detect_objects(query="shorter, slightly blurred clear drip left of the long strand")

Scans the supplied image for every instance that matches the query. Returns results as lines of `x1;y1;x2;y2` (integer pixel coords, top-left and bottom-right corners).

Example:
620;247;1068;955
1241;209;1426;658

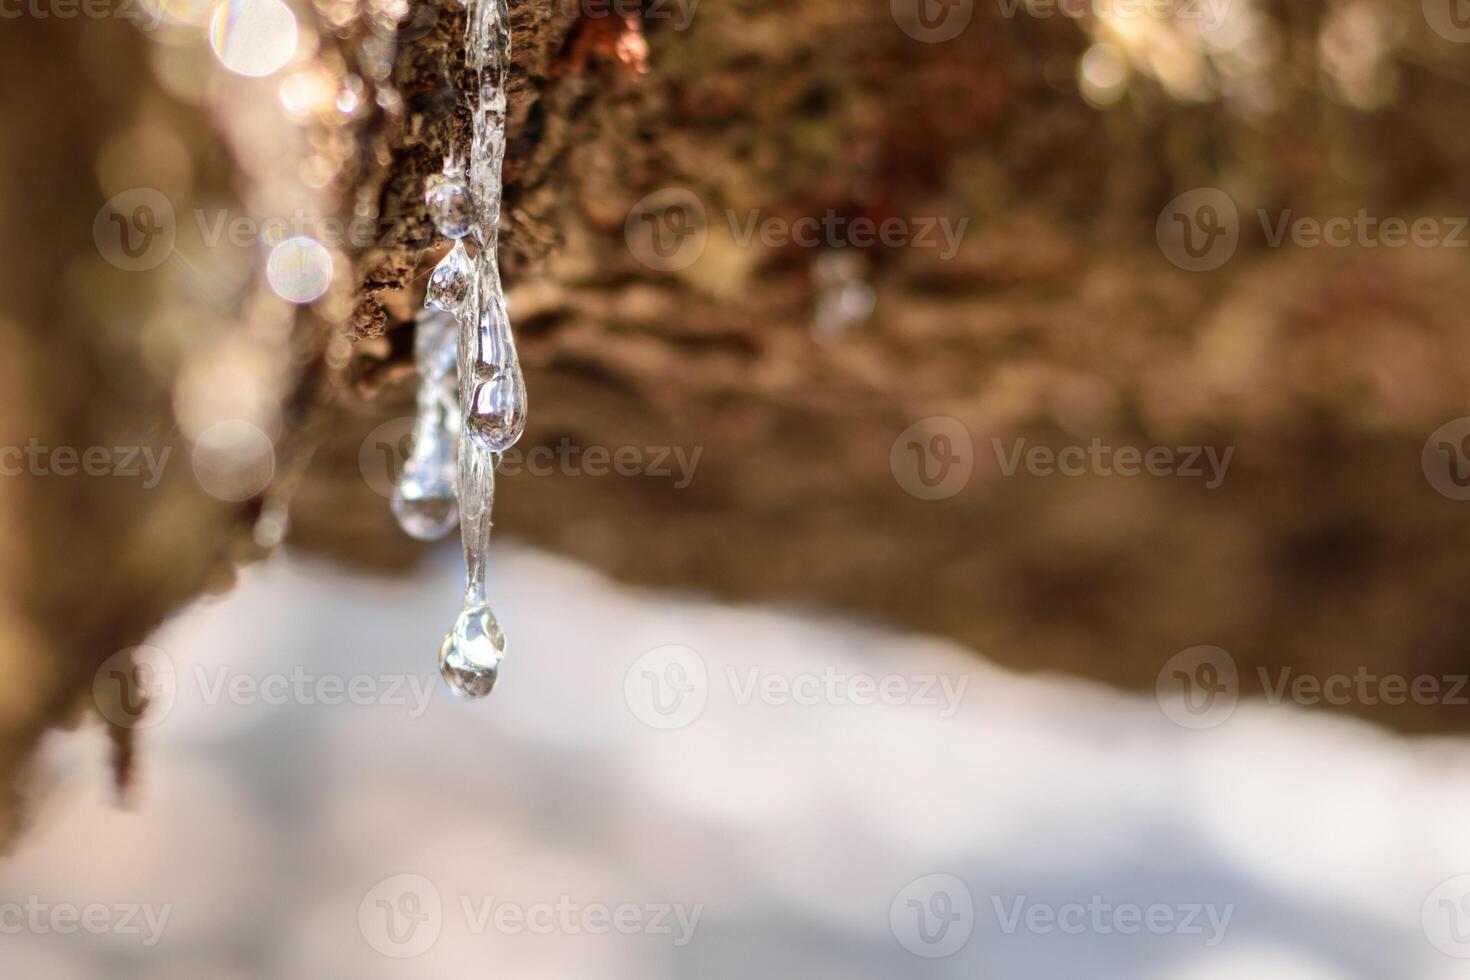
392;310;460;541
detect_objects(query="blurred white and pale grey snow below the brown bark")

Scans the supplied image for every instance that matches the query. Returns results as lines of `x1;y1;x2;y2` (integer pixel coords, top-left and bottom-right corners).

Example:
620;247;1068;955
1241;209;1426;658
0;545;1470;980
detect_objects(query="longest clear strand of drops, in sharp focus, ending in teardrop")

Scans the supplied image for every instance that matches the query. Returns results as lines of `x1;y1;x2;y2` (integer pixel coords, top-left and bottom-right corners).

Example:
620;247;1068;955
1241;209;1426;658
426;0;526;698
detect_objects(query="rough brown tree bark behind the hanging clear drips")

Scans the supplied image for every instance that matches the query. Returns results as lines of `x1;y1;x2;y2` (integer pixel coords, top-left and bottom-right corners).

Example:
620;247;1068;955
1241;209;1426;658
0;0;1470;840
